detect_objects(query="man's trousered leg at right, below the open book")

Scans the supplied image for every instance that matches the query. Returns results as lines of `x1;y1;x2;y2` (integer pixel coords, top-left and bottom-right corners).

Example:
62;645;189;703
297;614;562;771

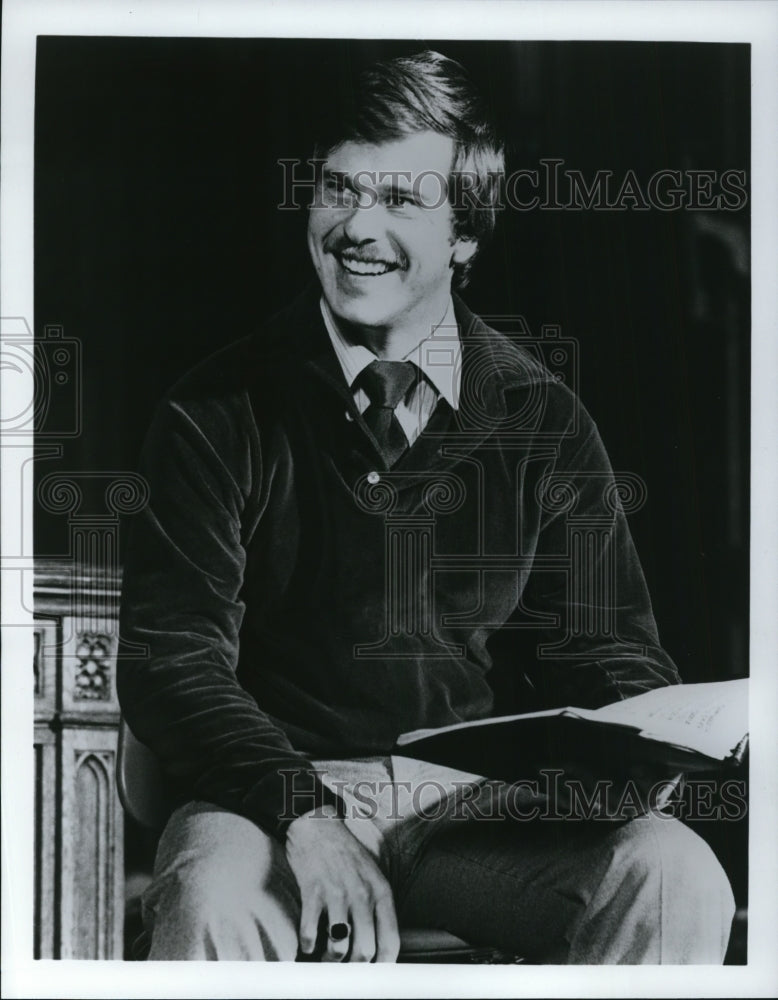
397;792;734;964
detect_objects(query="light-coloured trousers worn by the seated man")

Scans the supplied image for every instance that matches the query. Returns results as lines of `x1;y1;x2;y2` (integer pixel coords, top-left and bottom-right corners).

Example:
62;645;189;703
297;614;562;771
143;757;734;964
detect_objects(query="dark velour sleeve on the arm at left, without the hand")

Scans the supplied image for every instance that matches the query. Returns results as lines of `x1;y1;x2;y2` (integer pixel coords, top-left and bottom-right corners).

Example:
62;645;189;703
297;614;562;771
118;390;343;839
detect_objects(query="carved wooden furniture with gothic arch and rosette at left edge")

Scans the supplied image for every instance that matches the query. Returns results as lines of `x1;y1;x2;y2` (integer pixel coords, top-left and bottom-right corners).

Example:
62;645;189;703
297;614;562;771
32;563;124;959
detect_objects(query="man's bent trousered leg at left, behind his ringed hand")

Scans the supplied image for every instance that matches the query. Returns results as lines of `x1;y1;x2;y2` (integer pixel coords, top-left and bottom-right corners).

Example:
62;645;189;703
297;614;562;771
143;802;300;960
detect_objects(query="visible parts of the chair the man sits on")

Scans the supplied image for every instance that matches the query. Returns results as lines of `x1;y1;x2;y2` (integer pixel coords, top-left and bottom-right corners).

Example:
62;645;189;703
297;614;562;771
116;719;522;964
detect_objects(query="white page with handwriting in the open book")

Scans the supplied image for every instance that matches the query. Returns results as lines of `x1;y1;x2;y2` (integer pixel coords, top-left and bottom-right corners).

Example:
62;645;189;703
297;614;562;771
578;679;748;760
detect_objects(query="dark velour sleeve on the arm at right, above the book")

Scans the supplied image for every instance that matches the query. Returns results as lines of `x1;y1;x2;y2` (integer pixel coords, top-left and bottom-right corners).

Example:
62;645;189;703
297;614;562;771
522;378;680;708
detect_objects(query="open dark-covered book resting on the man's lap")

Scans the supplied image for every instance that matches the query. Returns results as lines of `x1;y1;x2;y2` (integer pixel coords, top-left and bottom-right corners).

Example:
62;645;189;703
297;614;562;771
395;679;748;781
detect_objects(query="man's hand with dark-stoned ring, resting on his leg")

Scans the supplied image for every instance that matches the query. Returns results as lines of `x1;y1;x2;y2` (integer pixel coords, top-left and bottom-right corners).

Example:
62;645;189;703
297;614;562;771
286;807;400;962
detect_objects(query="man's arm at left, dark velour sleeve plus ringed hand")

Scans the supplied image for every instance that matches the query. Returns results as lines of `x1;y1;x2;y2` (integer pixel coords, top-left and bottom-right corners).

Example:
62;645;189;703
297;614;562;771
118;386;399;961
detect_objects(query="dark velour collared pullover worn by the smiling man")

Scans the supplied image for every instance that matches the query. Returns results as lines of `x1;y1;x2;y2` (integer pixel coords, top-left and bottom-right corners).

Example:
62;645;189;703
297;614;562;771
118;291;678;835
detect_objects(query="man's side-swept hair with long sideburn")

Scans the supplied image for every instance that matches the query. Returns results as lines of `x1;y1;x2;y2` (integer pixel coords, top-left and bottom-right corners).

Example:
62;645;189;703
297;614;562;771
315;49;505;288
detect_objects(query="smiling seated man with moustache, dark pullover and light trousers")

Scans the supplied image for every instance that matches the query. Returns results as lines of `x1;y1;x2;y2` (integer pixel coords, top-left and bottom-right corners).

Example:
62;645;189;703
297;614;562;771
119;52;732;963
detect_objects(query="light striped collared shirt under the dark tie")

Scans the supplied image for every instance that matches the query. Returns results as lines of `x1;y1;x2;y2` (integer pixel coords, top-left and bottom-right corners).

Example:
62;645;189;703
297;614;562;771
320;296;462;444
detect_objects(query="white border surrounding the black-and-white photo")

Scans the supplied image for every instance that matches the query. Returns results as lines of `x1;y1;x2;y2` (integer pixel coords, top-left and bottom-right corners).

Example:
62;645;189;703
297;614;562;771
0;0;778;997
